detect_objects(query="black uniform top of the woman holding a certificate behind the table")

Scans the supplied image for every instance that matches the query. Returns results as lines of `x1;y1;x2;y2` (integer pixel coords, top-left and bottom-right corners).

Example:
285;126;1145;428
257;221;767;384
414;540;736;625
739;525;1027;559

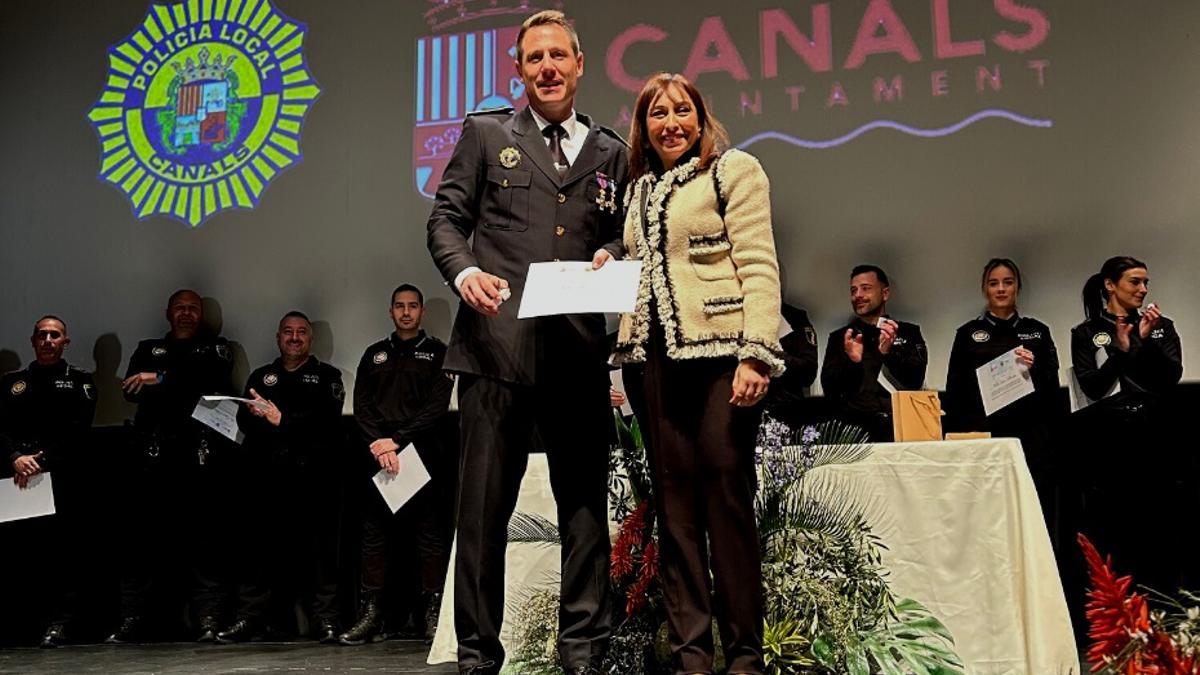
946;312;1058;435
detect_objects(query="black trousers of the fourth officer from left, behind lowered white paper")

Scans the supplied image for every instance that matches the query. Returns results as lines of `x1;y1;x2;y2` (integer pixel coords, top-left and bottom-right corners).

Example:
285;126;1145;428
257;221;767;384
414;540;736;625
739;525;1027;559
362;448;457;593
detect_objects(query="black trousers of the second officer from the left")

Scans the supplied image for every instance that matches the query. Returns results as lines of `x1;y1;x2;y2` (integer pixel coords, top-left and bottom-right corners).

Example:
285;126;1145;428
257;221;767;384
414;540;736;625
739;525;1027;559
120;453;228;617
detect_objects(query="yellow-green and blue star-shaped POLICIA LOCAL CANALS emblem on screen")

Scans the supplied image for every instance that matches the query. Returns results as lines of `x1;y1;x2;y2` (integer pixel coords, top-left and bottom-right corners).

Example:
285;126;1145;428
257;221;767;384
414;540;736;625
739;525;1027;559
88;0;320;227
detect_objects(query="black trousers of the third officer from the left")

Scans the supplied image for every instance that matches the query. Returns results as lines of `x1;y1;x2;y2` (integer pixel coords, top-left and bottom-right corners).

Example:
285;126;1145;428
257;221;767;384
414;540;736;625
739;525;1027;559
229;467;341;625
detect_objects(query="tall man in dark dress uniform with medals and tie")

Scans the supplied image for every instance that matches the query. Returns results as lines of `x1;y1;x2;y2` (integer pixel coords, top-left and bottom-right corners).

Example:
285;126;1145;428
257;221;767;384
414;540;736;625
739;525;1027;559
428;11;628;674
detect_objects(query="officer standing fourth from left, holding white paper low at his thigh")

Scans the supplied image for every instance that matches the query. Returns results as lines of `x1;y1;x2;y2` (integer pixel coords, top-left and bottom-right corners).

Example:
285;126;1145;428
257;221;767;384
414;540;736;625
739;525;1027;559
338;283;457;645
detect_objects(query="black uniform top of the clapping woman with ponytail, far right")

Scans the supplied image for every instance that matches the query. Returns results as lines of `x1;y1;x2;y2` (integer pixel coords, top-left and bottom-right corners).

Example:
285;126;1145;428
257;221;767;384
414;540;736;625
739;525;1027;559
1070;312;1183;400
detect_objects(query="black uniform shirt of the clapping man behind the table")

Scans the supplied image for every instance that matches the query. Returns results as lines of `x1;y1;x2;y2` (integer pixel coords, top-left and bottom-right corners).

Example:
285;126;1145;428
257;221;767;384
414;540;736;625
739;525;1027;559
821;317;929;413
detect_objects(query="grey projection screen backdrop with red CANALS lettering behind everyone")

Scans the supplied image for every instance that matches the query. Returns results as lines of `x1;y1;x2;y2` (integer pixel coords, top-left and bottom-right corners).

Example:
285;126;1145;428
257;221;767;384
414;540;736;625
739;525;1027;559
0;0;1200;423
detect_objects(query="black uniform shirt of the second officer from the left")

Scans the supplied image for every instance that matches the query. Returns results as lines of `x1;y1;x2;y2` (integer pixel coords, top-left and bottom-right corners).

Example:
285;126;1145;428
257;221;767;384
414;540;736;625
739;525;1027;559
125;335;233;435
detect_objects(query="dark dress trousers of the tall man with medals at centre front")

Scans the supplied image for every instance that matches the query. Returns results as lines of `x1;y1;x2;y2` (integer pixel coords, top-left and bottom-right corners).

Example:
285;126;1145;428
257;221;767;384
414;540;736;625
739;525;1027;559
455;369;612;668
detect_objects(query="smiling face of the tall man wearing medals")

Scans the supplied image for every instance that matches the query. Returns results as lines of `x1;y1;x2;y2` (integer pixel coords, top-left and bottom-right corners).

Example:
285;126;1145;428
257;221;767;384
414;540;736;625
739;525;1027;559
515;24;583;117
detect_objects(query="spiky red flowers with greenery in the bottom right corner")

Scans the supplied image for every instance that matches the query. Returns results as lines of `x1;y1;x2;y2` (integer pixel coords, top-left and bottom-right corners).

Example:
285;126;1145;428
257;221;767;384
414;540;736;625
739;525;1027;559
1078;533;1200;675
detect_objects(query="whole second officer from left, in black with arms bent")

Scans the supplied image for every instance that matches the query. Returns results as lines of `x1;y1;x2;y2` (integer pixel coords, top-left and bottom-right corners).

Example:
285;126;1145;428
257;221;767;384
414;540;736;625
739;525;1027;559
107;289;233;644
